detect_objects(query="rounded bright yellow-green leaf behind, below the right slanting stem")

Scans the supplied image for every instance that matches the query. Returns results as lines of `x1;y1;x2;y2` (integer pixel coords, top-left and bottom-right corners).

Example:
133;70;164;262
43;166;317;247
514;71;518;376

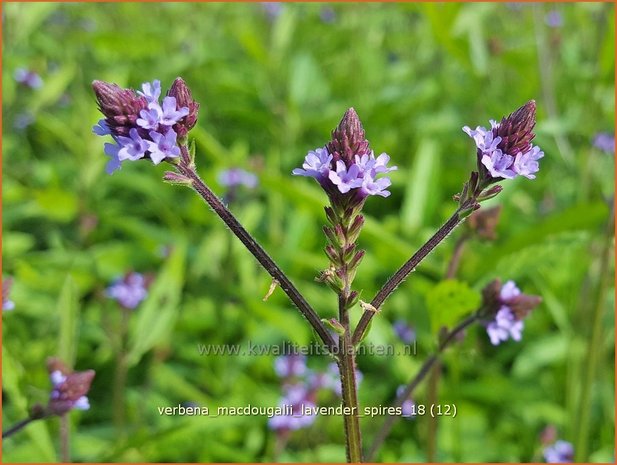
426;279;482;334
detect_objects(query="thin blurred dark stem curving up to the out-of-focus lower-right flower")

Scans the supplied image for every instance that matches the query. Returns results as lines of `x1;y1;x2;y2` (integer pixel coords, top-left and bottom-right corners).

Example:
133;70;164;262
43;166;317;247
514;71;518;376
366;312;479;462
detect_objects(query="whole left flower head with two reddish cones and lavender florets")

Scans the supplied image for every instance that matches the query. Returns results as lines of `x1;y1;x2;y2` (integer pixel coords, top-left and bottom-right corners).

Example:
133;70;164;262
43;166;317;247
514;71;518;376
92;78;191;174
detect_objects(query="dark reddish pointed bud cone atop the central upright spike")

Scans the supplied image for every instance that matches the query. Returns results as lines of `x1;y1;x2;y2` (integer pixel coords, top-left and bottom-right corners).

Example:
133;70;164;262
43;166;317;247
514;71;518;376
326;108;371;167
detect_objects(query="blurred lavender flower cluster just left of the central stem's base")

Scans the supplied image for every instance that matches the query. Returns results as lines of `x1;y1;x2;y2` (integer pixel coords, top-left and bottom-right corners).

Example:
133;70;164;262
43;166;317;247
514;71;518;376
268;354;362;432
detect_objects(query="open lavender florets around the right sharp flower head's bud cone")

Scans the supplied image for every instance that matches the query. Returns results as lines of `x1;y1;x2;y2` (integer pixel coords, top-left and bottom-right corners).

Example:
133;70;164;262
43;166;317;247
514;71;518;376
463;110;544;179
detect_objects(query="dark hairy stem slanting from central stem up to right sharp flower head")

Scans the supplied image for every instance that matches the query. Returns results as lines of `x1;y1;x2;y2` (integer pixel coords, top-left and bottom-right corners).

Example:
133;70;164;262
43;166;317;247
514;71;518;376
352;209;464;345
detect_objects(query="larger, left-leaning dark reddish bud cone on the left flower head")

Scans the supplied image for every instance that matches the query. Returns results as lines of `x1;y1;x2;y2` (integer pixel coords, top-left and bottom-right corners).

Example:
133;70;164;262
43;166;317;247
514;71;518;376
92;81;148;137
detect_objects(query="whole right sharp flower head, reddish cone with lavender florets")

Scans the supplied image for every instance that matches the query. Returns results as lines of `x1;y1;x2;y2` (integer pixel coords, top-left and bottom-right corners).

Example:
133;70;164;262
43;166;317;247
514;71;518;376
463;100;544;181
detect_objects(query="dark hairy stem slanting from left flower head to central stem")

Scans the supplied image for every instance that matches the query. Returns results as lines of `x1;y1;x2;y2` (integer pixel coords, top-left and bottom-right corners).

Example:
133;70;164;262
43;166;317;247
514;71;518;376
176;149;336;352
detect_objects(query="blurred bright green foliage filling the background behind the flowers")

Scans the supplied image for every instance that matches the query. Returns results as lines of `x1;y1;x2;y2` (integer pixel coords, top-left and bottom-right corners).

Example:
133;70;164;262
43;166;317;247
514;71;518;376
2;3;615;462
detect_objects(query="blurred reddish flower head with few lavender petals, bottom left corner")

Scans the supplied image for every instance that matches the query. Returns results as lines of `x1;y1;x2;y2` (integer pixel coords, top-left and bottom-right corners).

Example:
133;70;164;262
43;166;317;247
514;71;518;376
47;358;95;415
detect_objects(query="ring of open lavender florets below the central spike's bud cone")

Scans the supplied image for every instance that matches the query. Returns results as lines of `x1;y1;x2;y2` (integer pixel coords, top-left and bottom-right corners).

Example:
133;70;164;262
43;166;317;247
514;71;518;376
292;147;397;197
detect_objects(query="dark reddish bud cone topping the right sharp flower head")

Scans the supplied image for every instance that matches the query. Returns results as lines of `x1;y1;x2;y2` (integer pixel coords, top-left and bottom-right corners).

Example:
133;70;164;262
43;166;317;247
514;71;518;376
493;100;536;156
